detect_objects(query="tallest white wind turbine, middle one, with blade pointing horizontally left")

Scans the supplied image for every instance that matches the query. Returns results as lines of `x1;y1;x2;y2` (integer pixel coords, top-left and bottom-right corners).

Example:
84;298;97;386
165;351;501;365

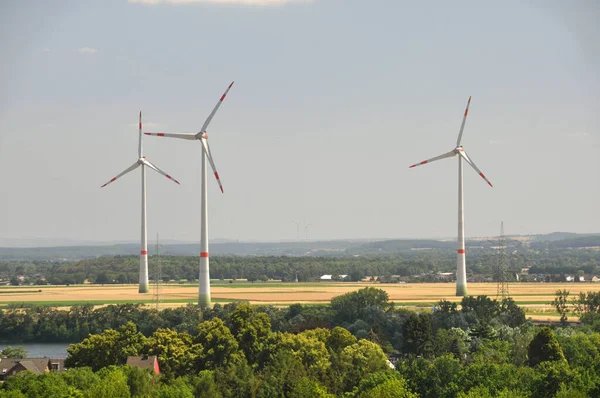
144;82;234;308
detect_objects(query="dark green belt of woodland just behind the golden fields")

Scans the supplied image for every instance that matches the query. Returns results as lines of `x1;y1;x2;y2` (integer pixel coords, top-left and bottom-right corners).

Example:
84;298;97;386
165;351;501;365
0;249;600;284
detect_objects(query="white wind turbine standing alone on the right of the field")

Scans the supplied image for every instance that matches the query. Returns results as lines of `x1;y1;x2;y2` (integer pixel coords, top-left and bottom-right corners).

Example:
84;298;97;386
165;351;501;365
410;97;493;296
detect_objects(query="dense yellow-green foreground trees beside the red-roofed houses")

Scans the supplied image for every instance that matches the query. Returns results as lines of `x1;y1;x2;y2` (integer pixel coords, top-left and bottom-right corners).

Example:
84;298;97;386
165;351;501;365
5;288;600;398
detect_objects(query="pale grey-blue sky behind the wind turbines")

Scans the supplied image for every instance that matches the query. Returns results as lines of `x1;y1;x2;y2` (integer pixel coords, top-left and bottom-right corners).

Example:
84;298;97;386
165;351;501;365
0;0;600;241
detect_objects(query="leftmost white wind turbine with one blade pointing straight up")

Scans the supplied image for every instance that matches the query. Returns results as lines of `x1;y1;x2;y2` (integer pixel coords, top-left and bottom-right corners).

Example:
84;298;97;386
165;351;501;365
101;111;179;293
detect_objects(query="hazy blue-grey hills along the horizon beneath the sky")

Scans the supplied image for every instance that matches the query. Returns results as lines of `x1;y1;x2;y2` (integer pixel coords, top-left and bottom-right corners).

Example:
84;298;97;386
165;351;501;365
0;232;600;261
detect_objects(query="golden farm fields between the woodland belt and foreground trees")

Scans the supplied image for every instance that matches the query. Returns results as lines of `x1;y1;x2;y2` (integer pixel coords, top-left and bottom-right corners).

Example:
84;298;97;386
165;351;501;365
0;281;600;320
